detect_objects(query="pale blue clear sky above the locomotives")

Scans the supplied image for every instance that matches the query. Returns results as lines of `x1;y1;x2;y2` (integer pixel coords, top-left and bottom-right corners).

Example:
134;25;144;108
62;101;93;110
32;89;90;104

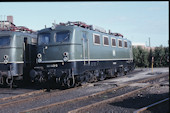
0;1;169;47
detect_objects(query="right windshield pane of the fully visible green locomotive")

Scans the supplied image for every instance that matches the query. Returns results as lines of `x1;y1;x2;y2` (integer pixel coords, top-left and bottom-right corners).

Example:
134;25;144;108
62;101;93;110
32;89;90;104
55;31;70;43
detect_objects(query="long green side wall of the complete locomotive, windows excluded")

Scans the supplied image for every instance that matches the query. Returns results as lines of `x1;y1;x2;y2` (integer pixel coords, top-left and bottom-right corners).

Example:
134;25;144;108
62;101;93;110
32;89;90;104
70;27;133;74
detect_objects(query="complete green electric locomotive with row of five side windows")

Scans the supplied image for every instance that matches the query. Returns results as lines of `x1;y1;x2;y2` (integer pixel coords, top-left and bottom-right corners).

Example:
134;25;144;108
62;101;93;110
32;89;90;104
30;21;134;88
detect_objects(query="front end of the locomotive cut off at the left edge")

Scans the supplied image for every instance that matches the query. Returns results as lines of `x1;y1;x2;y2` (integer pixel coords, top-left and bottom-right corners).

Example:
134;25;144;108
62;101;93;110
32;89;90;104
0;32;23;85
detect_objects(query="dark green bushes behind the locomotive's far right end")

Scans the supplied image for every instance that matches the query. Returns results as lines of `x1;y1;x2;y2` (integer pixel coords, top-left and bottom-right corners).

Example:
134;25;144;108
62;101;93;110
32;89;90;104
133;45;169;67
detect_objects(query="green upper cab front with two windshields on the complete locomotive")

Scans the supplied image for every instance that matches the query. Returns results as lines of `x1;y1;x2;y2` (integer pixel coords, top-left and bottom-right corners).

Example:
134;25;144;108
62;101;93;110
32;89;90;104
37;27;72;63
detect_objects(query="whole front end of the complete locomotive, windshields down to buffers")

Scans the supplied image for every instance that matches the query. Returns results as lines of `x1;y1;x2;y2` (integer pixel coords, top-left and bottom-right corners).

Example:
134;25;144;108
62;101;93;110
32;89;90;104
30;26;72;87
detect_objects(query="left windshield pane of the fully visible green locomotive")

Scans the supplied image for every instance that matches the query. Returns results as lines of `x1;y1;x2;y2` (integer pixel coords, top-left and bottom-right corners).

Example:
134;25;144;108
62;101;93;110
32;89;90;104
38;33;50;45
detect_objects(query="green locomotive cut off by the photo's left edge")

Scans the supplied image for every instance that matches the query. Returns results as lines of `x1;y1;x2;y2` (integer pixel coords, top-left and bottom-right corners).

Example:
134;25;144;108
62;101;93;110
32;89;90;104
0;26;37;87
